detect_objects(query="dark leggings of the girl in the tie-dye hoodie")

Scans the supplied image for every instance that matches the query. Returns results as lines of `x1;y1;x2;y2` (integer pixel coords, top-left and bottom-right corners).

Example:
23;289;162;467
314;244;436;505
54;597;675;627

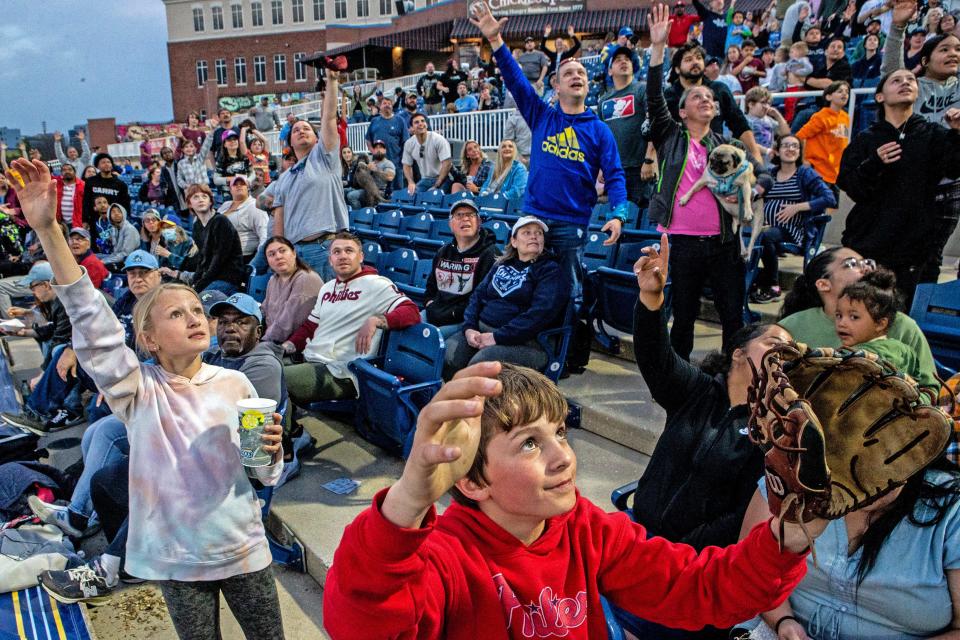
159;567;284;640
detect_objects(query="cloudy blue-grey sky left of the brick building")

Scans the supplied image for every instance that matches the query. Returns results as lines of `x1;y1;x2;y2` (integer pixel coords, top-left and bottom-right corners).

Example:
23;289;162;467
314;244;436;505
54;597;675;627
0;0;172;135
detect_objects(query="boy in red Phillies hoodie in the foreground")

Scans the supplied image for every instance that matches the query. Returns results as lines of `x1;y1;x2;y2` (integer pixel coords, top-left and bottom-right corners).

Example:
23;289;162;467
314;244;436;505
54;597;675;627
323;358;825;640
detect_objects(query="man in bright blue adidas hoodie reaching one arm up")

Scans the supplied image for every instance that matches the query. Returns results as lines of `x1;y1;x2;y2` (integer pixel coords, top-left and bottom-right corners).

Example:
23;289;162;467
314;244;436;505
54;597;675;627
470;2;628;292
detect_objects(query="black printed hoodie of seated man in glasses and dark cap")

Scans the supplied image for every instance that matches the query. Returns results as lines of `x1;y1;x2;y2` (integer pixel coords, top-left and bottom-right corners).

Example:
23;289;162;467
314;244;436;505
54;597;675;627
425;227;500;327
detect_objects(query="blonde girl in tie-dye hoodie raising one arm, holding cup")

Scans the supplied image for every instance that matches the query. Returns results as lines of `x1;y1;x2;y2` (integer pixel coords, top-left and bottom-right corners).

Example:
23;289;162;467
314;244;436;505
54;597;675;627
6;160;283;639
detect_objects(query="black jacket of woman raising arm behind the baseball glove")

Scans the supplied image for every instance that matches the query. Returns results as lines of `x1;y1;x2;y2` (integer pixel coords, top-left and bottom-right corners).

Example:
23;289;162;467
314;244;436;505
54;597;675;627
633;303;763;550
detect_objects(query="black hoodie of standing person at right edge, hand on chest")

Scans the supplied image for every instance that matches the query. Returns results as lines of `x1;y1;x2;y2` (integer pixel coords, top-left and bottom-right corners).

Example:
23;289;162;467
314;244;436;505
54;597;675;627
837;115;960;268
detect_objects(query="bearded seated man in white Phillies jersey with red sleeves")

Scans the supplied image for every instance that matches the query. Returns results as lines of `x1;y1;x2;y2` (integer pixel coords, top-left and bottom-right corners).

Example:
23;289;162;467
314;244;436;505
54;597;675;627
282;231;420;407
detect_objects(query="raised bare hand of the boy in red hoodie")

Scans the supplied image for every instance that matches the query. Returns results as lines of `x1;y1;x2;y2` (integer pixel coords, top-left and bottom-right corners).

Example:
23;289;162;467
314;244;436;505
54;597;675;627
382;362;502;527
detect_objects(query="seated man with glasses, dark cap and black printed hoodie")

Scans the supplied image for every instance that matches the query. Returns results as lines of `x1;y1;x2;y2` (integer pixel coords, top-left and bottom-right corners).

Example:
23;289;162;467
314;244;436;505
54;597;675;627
422;200;499;338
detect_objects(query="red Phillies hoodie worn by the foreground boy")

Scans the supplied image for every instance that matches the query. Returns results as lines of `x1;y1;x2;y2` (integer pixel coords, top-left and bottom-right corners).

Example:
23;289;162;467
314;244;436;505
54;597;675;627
323;489;806;640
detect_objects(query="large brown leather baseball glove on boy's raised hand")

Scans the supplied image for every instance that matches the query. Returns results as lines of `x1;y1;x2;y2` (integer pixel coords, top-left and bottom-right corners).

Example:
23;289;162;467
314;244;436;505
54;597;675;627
749;344;951;524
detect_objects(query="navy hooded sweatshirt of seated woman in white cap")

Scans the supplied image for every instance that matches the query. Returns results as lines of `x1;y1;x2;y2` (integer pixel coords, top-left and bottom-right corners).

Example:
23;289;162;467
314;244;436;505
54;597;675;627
463;253;570;345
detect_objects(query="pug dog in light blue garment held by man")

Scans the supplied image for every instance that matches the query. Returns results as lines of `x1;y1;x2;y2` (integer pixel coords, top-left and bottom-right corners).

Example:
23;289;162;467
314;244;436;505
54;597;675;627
680;140;763;257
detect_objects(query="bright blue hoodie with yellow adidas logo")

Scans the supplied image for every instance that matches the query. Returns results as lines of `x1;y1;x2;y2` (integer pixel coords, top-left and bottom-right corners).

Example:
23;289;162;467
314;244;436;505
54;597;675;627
493;46;627;226
